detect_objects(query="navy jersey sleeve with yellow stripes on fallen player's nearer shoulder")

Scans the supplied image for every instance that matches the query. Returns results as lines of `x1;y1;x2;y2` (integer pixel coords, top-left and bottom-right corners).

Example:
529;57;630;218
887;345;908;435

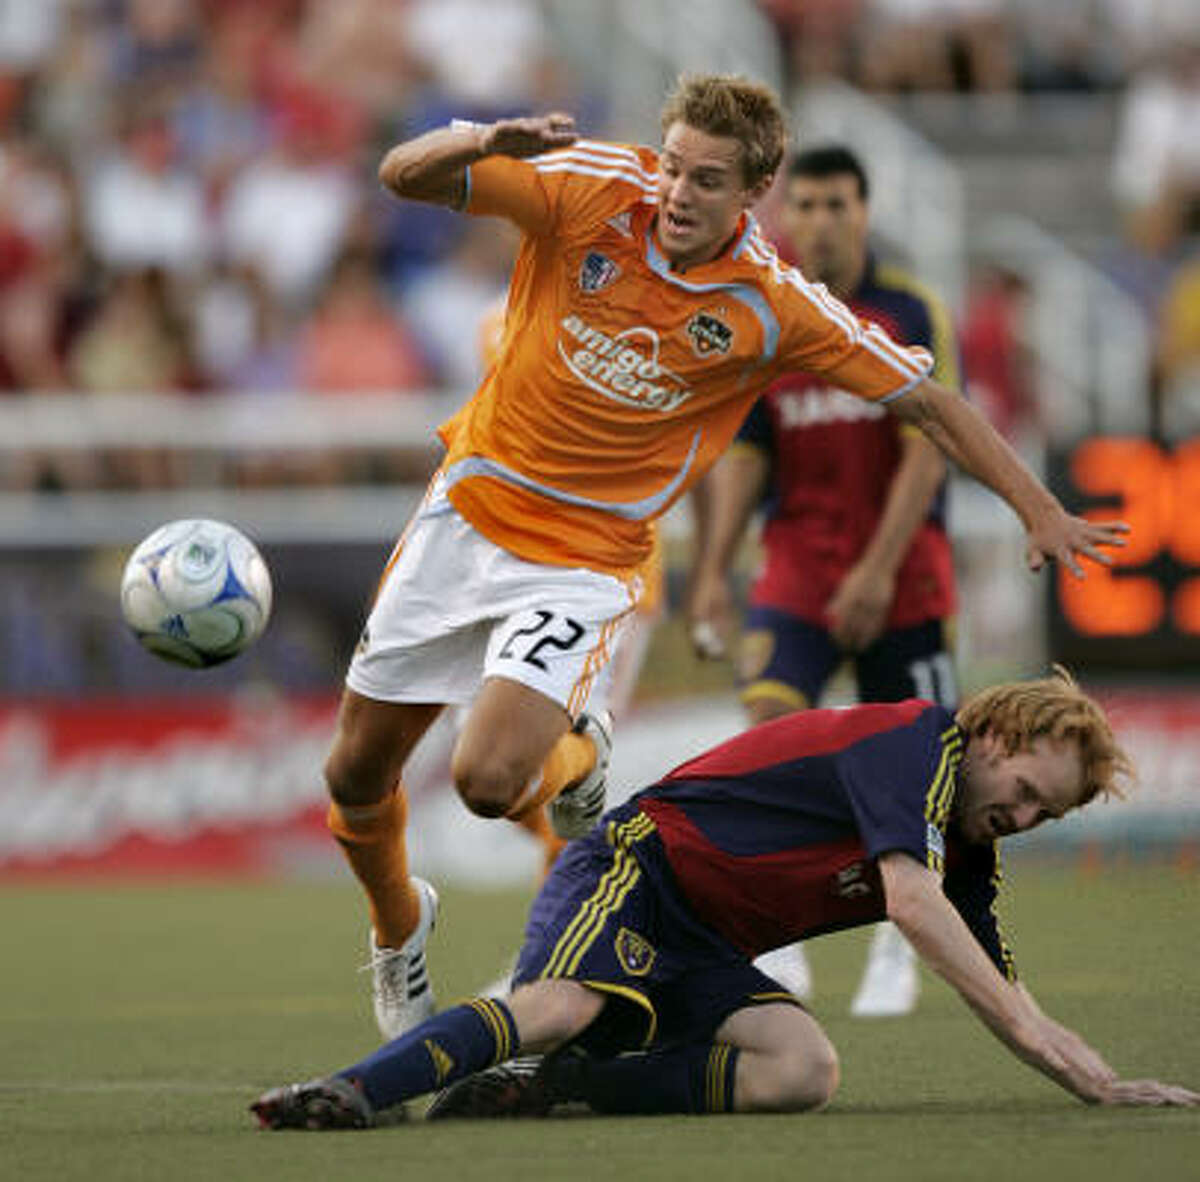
838;707;962;875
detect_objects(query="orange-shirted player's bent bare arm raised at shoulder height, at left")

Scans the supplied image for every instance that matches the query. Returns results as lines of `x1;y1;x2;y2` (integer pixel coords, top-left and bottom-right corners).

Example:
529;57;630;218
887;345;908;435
379;112;576;209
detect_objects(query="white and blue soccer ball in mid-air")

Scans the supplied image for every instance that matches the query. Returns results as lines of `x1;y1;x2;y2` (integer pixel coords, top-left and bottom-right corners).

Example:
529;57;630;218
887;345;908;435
121;520;271;668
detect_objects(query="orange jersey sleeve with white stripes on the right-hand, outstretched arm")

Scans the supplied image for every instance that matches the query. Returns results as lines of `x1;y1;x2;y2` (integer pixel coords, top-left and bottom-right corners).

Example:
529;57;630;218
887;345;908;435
778;269;934;402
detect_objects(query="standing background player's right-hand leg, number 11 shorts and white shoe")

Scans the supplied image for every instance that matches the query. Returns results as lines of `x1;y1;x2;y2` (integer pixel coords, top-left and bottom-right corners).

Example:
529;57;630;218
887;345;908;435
850;620;958;1018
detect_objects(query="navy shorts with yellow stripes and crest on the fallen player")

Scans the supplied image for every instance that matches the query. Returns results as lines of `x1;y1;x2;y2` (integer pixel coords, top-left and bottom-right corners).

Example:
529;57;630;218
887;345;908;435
512;802;799;1055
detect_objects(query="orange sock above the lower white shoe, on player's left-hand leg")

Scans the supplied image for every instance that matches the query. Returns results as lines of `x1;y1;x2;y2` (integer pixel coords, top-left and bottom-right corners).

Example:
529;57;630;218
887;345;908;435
325;785;421;948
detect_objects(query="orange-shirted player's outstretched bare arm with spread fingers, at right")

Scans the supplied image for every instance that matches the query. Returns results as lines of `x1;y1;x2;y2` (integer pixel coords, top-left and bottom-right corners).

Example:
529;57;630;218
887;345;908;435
890;379;1129;577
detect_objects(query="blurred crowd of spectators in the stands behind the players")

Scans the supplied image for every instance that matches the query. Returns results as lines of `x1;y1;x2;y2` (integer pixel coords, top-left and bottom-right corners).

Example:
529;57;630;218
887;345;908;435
0;0;1200;487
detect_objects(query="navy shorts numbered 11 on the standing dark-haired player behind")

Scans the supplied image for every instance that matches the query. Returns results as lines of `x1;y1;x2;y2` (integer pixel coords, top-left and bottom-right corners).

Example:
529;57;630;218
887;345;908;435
738;606;958;710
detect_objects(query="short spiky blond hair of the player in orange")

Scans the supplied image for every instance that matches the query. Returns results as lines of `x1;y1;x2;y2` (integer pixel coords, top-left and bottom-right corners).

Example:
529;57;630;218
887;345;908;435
659;74;787;188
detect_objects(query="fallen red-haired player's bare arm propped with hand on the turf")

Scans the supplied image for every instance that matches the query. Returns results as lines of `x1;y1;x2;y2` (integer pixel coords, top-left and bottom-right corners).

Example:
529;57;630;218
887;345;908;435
880;852;1200;1108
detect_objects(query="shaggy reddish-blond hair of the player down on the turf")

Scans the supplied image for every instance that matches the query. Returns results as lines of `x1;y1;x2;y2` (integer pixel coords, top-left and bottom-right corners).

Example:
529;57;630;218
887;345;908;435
955;665;1136;804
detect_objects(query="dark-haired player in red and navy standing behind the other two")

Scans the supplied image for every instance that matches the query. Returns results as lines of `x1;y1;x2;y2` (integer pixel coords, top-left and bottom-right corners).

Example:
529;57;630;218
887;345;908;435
691;144;959;1016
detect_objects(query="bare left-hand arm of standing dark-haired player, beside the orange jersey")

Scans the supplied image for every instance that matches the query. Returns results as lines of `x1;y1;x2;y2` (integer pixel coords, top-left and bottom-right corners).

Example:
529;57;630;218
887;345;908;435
688;445;770;658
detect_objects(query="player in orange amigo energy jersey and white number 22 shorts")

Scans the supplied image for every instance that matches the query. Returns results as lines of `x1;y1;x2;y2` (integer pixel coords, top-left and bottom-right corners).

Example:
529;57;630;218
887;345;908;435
325;76;1121;1036
